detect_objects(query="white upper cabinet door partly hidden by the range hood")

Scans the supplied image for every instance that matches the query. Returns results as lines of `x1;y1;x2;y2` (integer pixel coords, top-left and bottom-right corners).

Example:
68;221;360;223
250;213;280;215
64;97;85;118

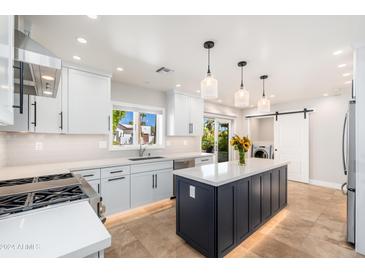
29;85;63;133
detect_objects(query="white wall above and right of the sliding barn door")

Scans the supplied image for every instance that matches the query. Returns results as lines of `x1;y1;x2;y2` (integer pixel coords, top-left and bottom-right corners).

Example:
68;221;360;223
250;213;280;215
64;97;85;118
244;94;350;187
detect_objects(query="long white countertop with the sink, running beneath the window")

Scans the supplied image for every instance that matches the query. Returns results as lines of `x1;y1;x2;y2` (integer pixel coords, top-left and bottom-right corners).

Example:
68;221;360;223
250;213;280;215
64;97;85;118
0;152;213;181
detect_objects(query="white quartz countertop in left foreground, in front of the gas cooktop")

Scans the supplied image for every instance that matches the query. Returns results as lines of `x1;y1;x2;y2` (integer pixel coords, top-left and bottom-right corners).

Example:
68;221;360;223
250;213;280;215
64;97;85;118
0;201;111;258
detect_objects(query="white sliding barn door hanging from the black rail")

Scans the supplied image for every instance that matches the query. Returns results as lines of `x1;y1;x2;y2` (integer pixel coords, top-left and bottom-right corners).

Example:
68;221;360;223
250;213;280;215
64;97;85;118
274;113;309;183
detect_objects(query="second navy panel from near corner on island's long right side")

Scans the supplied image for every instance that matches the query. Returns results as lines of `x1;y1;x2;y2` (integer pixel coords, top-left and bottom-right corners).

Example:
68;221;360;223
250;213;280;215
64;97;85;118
235;179;250;243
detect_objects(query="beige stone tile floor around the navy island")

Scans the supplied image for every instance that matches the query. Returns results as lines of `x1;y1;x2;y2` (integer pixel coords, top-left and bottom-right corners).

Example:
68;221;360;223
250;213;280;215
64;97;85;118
105;182;361;258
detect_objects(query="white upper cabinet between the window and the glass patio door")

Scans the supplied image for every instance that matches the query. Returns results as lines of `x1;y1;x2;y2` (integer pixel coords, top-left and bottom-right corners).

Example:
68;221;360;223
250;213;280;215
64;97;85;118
166;92;204;136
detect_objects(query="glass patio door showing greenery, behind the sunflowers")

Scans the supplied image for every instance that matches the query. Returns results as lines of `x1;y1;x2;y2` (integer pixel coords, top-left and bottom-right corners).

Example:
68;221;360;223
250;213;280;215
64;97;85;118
201;117;232;163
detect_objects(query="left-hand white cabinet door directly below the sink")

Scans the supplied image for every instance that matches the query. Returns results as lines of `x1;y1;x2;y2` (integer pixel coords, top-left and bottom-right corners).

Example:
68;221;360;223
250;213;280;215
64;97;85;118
131;172;155;207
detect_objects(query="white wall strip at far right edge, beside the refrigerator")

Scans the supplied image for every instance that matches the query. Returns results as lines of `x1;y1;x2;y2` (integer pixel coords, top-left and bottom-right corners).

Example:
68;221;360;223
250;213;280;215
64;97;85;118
354;47;365;255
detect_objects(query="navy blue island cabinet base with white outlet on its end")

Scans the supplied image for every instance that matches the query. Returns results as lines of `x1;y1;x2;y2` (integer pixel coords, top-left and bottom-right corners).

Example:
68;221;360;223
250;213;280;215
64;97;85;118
176;165;288;258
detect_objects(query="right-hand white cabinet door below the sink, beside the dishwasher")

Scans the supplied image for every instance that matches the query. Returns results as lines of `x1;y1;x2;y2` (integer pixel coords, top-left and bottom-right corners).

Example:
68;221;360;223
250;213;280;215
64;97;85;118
153;169;174;201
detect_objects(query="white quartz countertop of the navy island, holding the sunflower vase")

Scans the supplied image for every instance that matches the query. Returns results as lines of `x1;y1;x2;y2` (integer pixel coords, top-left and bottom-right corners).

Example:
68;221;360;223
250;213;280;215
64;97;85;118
174;158;288;186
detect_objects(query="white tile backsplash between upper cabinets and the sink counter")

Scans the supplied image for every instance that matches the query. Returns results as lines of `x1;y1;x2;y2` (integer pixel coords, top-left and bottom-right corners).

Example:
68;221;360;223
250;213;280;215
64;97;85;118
0;133;200;166
